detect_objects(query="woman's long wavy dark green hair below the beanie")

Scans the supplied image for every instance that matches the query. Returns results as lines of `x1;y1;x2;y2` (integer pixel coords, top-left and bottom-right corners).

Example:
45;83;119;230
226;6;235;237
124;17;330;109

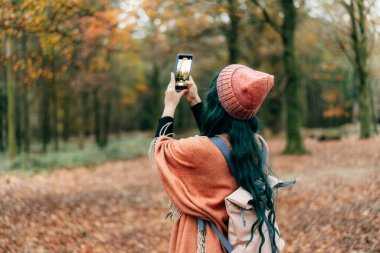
201;74;278;252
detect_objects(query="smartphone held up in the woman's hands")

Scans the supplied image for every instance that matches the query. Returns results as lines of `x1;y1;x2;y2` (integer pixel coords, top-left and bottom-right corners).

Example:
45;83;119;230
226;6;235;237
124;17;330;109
174;54;193;90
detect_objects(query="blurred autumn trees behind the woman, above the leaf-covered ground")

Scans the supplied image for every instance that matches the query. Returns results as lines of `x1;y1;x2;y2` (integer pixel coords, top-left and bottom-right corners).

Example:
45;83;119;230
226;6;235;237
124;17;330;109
0;0;380;157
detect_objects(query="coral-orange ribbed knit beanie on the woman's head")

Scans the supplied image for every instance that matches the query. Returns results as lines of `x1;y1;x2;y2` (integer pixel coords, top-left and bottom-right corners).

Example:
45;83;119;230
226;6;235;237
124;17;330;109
217;64;274;120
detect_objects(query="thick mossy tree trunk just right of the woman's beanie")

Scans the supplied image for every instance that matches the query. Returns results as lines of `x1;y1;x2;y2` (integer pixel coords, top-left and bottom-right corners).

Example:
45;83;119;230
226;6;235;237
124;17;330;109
281;0;305;154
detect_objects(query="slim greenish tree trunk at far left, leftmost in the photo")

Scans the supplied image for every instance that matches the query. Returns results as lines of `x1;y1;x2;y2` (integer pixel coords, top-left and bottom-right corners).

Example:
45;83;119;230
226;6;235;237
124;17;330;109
6;36;16;158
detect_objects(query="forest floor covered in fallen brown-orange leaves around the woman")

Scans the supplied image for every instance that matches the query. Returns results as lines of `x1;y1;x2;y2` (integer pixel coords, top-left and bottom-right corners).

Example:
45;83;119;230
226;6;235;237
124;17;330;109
0;137;380;253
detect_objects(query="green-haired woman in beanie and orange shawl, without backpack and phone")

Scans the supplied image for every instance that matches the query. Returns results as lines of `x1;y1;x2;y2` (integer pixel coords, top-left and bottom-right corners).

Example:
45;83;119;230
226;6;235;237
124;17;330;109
150;64;275;253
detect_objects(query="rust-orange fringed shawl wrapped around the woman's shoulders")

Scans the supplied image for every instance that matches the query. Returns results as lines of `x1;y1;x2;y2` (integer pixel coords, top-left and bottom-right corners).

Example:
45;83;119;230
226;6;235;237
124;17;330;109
154;135;238;253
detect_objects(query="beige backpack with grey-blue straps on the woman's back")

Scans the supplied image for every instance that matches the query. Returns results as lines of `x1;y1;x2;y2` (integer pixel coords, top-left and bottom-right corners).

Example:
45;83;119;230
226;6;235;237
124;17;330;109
198;135;296;253
